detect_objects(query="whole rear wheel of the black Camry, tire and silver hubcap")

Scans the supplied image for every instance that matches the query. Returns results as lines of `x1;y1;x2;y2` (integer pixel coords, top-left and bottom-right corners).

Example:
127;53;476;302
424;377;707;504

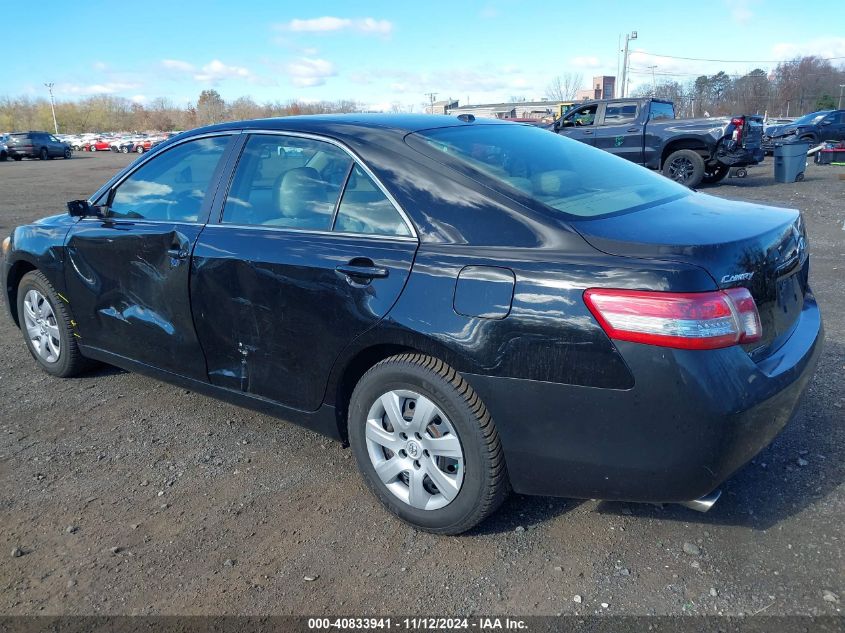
349;354;510;534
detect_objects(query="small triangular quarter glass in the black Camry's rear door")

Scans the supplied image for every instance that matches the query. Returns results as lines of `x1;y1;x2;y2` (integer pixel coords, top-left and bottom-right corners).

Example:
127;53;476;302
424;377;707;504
334;165;411;236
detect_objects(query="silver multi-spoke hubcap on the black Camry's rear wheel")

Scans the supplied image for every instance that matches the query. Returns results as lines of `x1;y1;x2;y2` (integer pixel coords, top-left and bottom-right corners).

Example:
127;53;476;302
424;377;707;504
365;390;465;510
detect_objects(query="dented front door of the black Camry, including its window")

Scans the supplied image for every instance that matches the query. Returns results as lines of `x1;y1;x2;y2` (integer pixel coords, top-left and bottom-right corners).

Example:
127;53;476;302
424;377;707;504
65;135;232;380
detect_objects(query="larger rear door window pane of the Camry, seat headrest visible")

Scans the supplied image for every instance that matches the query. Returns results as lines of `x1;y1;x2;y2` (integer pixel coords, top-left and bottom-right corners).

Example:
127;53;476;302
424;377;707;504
223;134;352;231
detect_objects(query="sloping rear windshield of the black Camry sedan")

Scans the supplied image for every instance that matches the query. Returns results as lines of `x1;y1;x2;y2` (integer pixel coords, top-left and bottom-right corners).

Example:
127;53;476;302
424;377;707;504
408;124;690;218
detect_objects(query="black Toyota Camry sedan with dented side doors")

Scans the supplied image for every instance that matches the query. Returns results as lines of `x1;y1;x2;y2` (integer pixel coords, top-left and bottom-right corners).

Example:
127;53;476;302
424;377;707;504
3;115;822;534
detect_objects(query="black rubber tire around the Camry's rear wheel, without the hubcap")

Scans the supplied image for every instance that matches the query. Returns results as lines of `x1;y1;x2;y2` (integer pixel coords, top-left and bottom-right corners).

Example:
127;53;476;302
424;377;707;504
349;354;510;534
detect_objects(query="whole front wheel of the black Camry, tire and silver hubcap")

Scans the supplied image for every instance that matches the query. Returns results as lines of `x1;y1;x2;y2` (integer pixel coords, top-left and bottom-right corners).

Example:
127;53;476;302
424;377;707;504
18;270;88;378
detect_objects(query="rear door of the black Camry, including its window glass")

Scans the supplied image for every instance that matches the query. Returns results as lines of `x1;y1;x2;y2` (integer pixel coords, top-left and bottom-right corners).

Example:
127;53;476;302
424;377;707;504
191;134;417;411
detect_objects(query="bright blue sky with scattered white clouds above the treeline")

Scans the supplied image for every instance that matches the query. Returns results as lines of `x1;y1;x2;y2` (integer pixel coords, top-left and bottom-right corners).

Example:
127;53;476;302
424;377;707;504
6;0;845;110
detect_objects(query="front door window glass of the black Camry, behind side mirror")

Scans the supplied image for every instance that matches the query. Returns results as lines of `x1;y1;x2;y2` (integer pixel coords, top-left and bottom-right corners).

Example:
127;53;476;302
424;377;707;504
108;136;229;222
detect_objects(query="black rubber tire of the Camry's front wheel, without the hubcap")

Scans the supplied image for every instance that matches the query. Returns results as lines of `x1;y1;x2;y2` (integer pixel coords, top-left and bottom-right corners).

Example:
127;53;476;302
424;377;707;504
18;270;90;378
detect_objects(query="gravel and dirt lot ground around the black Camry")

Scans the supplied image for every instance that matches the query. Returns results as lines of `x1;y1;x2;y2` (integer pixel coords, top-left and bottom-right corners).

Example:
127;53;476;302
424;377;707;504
0;154;845;615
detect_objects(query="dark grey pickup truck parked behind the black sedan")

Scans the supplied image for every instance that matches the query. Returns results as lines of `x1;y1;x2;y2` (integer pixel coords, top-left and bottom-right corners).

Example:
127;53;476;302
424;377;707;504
553;98;765;187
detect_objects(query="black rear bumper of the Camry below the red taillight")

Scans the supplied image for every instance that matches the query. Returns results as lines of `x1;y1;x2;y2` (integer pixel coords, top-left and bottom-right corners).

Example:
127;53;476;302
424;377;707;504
465;296;823;502
